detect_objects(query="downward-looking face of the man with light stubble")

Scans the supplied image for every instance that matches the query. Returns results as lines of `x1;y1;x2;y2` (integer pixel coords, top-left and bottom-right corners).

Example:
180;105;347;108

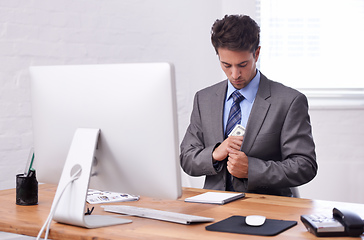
218;47;260;89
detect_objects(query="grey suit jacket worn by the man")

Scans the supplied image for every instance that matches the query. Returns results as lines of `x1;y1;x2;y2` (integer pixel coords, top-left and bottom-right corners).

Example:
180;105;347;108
180;74;317;196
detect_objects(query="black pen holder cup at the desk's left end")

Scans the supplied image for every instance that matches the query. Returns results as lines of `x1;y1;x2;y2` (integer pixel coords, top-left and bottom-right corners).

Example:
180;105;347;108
16;172;38;206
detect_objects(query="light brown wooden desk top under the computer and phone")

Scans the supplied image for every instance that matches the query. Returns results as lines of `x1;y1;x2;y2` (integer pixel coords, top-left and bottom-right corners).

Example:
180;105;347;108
0;184;364;240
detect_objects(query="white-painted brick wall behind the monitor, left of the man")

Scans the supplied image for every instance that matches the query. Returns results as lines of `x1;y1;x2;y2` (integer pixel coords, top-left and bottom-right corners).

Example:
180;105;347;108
0;0;221;188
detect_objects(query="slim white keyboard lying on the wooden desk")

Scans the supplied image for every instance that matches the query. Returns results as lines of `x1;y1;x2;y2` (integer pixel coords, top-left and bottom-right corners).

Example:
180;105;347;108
101;205;215;224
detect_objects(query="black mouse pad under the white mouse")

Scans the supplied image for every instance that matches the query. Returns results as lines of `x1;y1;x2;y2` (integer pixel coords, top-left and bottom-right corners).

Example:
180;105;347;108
206;216;297;236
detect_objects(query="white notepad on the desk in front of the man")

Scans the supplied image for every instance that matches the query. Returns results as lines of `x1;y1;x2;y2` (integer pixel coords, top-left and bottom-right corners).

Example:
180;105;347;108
185;192;245;204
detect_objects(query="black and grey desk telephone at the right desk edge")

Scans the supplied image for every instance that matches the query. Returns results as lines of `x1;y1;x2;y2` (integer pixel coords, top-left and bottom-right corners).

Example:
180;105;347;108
301;208;364;237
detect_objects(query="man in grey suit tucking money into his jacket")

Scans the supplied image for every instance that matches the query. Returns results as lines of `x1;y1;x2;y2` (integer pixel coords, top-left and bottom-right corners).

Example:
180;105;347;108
180;15;317;196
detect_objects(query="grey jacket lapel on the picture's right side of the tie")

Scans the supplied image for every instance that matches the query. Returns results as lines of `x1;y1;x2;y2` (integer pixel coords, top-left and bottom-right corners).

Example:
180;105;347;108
241;74;270;155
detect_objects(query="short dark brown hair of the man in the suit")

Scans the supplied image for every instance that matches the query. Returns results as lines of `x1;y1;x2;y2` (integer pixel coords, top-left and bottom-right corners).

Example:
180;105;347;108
211;15;260;54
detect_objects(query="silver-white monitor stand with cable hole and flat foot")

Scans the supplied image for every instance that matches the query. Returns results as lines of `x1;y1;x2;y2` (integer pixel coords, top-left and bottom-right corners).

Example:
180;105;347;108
52;128;132;228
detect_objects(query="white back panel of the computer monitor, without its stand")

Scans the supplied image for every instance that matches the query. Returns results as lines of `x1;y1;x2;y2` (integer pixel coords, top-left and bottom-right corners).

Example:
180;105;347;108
30;63;181;199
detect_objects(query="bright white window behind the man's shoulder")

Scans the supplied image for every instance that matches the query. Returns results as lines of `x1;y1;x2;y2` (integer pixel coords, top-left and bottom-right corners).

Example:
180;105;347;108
257;0;364;91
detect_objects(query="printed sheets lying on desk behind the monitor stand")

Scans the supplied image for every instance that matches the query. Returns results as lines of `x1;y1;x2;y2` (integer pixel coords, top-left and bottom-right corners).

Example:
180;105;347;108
86;189;139;204
